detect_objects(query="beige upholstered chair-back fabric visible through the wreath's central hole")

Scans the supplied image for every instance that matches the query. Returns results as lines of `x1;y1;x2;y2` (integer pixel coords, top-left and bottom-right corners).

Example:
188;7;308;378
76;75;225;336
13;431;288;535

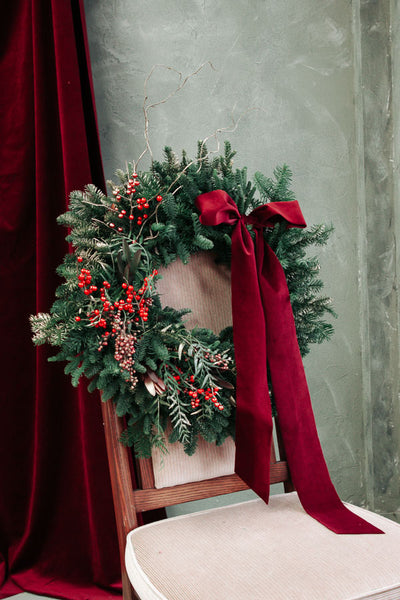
157;252;232;333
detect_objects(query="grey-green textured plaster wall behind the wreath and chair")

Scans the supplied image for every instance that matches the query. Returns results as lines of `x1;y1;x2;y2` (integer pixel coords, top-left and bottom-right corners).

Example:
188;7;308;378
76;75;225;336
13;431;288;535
85;0;400;515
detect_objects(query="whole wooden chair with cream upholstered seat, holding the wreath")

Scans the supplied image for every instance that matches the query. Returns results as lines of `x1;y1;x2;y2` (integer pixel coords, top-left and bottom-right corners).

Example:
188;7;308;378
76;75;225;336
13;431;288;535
102;254;400;600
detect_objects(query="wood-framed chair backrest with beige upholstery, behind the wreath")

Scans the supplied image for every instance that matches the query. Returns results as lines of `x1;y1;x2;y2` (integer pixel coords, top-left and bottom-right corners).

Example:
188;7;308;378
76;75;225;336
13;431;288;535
102;253;293;598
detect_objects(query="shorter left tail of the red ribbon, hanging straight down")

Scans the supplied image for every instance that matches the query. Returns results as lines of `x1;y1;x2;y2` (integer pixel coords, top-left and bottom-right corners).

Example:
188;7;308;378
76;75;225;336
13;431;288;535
232;223;272;502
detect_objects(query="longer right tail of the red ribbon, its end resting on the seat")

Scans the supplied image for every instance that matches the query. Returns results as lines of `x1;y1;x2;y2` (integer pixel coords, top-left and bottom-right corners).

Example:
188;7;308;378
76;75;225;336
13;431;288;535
260;236;382;534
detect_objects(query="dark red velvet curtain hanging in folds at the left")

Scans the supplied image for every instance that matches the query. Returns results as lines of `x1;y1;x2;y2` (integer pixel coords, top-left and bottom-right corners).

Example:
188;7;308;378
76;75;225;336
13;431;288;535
0;0;120;600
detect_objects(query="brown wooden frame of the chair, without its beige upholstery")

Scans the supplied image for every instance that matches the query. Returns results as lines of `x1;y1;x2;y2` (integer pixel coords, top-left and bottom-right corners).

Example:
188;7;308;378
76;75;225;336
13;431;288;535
101;400;294;600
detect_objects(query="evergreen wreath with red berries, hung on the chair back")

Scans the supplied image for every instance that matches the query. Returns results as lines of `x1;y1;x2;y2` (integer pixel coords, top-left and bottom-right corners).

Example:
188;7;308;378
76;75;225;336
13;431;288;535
31;142;334;457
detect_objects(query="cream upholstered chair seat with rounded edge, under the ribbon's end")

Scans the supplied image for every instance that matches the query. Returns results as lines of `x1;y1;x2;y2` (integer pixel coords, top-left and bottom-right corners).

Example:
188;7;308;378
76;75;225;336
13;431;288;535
126;492;400;600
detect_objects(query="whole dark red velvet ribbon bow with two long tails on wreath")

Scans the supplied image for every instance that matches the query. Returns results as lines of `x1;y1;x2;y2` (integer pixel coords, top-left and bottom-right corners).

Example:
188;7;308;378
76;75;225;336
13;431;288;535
196;190;382;533
